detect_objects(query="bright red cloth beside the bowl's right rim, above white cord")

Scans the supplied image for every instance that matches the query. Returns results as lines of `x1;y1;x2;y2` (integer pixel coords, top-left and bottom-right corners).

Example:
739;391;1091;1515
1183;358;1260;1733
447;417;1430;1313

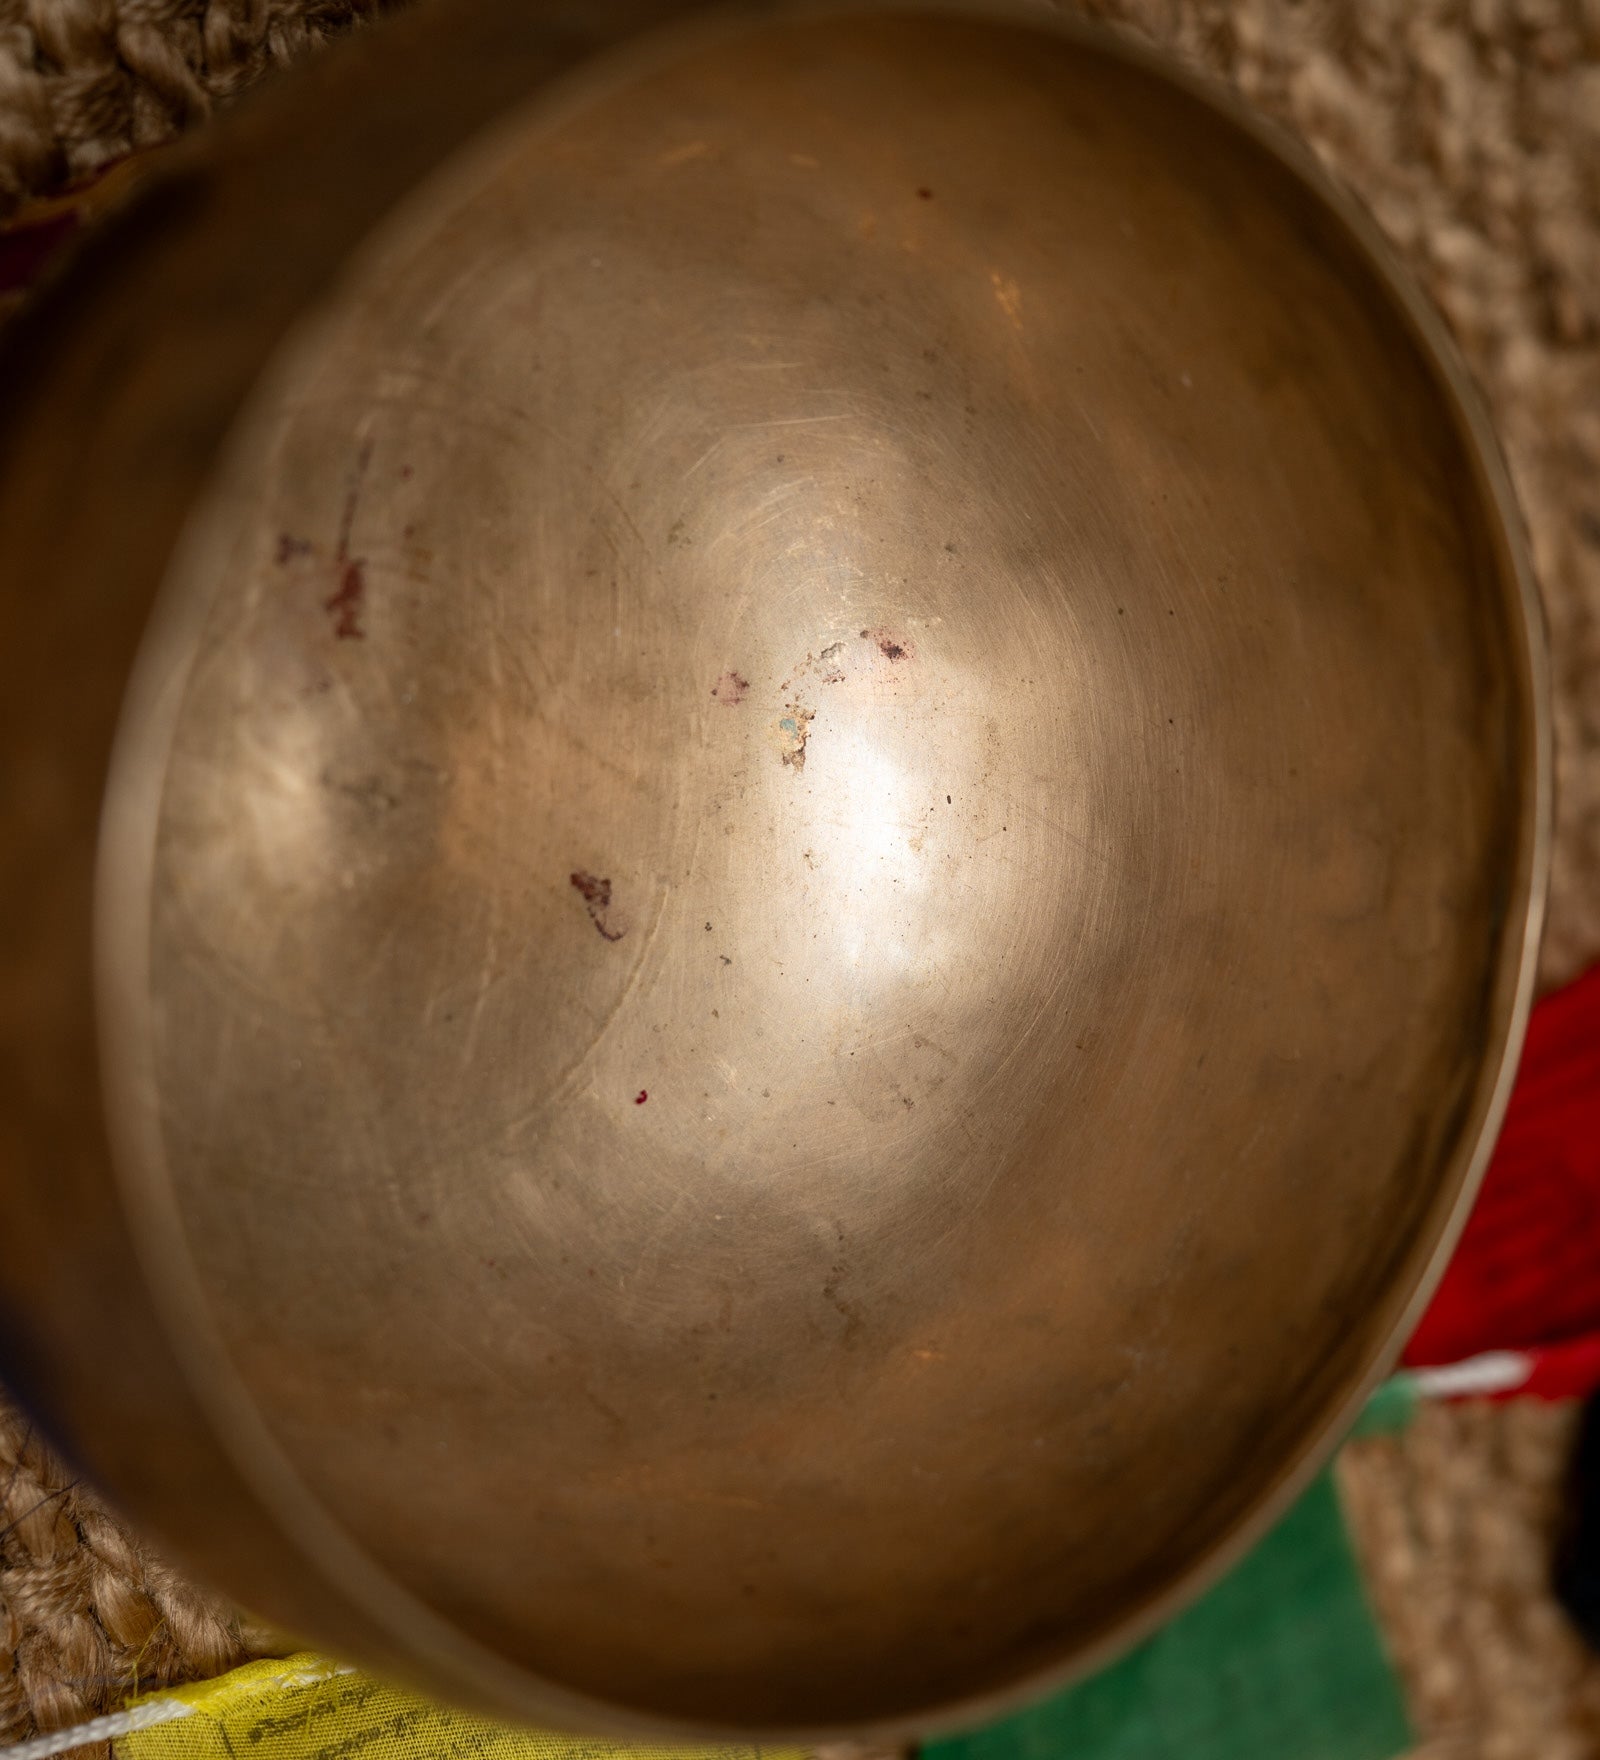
1405;966;1600;1392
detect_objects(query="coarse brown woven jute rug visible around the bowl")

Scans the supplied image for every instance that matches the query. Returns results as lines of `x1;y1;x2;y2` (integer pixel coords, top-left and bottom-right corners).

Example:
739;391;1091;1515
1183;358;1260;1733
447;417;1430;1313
0;0;1600;1760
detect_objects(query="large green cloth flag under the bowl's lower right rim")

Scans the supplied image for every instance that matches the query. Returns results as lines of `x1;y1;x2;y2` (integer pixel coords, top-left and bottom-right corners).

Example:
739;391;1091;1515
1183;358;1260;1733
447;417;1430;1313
922;1473;1412;1760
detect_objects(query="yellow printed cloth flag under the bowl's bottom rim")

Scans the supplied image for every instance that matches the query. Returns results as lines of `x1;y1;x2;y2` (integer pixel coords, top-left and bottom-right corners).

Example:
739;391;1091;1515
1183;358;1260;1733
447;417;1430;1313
113;1654;803;1760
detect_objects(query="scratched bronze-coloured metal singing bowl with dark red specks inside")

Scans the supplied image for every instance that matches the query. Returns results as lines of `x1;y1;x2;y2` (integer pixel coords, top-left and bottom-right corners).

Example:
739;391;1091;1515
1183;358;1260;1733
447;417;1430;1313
0;0;1547;1732
